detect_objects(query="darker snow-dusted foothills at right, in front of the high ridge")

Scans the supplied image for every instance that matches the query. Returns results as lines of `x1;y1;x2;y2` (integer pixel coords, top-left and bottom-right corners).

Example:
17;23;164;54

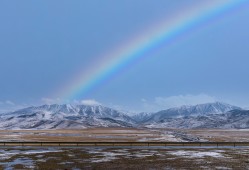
145;110;249;129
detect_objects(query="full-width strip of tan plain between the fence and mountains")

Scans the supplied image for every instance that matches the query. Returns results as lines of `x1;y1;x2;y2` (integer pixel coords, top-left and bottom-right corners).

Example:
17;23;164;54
0;128;249;142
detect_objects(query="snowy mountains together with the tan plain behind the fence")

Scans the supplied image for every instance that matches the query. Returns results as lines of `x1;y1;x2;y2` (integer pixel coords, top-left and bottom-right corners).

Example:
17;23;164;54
0;102;249;142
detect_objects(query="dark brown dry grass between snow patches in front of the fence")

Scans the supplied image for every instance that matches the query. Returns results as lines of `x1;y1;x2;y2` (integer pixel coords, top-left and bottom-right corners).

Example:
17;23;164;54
2;148;249;170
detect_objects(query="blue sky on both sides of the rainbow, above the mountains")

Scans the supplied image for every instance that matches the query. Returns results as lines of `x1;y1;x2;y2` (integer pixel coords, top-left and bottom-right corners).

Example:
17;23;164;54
0;0;249;111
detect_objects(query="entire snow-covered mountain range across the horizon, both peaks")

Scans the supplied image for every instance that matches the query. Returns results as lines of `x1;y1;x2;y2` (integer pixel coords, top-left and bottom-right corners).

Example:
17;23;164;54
0;102;249;129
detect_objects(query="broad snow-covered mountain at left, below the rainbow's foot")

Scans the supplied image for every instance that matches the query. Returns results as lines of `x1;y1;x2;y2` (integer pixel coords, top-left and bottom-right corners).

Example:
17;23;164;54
0;104;135;129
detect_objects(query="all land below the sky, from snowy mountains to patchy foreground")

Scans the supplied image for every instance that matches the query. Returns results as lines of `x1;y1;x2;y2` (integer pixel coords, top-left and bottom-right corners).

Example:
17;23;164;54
0;102;249;170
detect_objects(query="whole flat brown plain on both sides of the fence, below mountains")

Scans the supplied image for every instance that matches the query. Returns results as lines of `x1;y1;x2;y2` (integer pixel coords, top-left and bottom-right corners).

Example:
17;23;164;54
0;128;249;170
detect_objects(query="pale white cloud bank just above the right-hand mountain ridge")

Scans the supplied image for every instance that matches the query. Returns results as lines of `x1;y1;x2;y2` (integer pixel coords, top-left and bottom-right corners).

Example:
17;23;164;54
142;93;216;112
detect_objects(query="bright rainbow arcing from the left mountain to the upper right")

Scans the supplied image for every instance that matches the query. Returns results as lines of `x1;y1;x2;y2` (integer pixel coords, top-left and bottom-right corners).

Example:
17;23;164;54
56;0;245;101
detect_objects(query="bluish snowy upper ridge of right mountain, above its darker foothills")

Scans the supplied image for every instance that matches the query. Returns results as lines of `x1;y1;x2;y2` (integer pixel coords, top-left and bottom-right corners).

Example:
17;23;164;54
143;102;241;124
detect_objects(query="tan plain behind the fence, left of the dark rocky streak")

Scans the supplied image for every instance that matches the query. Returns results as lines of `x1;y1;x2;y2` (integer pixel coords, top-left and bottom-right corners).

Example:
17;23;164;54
0;128;180;142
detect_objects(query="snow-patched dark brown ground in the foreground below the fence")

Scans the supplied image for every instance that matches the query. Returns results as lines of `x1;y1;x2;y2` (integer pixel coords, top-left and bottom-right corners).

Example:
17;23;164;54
0;147;249;170
